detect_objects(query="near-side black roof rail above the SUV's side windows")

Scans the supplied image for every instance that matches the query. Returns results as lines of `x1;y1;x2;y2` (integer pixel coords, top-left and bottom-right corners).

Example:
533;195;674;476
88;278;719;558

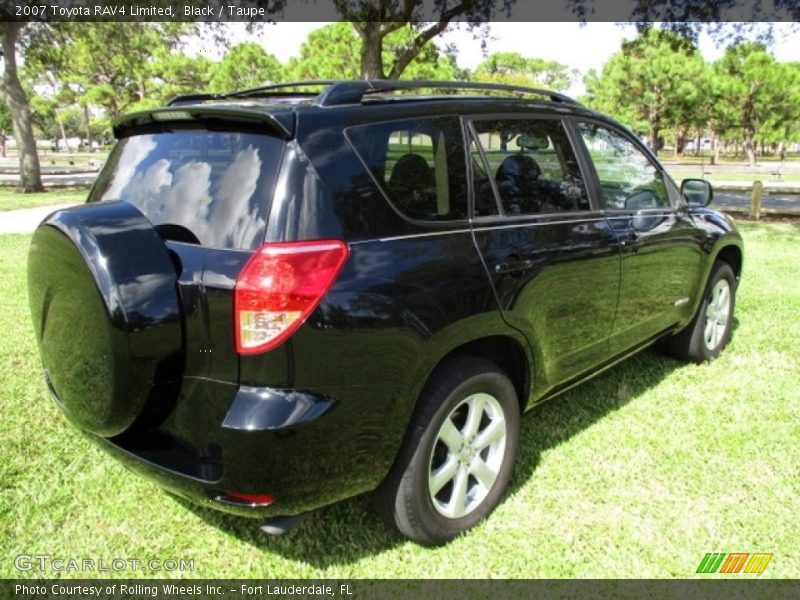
316;79;580;106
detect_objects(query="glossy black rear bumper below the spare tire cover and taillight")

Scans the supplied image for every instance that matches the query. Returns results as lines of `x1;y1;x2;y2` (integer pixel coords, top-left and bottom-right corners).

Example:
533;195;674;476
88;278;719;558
54;378;402;518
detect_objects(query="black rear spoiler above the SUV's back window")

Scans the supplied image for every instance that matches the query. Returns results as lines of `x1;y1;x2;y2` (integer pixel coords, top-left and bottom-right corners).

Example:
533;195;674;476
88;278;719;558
112;105;294;140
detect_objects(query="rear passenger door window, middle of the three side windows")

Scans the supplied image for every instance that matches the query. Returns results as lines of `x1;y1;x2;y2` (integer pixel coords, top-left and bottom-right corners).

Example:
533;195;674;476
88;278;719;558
470;119;589;216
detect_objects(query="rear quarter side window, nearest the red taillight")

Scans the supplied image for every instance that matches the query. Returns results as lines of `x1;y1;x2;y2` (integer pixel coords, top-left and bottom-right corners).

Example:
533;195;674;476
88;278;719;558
347;118;467;221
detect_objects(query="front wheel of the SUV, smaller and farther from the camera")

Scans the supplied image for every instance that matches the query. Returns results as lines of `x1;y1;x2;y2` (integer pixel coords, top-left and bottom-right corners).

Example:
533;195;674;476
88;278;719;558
667;261;736;363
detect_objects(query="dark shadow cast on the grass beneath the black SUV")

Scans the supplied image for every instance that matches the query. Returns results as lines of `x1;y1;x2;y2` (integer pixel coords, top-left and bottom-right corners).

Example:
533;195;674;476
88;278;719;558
175;350;684;568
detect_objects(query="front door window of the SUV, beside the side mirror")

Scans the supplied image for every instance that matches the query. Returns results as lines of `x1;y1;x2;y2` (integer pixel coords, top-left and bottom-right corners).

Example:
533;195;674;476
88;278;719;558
578;123;670;209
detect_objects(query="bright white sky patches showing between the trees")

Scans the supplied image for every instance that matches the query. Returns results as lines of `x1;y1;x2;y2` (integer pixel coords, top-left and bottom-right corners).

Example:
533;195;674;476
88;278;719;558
197;22;800;96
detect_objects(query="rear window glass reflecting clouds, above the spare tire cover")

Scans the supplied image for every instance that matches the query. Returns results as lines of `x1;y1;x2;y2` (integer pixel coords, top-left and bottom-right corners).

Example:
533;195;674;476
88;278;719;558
89;130;283;250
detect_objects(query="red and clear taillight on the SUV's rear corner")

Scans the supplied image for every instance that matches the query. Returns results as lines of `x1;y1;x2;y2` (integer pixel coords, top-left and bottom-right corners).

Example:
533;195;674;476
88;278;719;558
234;240;349;354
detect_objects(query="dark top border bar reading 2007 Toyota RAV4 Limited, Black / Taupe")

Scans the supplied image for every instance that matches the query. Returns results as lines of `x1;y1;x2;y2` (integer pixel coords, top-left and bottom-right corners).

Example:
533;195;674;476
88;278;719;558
0;0;800;23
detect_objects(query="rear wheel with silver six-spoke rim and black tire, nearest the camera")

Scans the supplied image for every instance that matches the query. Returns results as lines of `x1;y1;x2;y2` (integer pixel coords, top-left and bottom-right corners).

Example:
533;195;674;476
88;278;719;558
376;357;520;545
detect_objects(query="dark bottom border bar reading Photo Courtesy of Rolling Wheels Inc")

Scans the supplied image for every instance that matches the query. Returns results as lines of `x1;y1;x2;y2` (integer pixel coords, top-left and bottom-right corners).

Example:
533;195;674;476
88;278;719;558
0;575;800;600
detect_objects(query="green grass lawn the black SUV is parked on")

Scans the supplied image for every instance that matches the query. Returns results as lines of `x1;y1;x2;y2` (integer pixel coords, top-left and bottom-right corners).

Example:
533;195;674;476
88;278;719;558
0;223;800;578
